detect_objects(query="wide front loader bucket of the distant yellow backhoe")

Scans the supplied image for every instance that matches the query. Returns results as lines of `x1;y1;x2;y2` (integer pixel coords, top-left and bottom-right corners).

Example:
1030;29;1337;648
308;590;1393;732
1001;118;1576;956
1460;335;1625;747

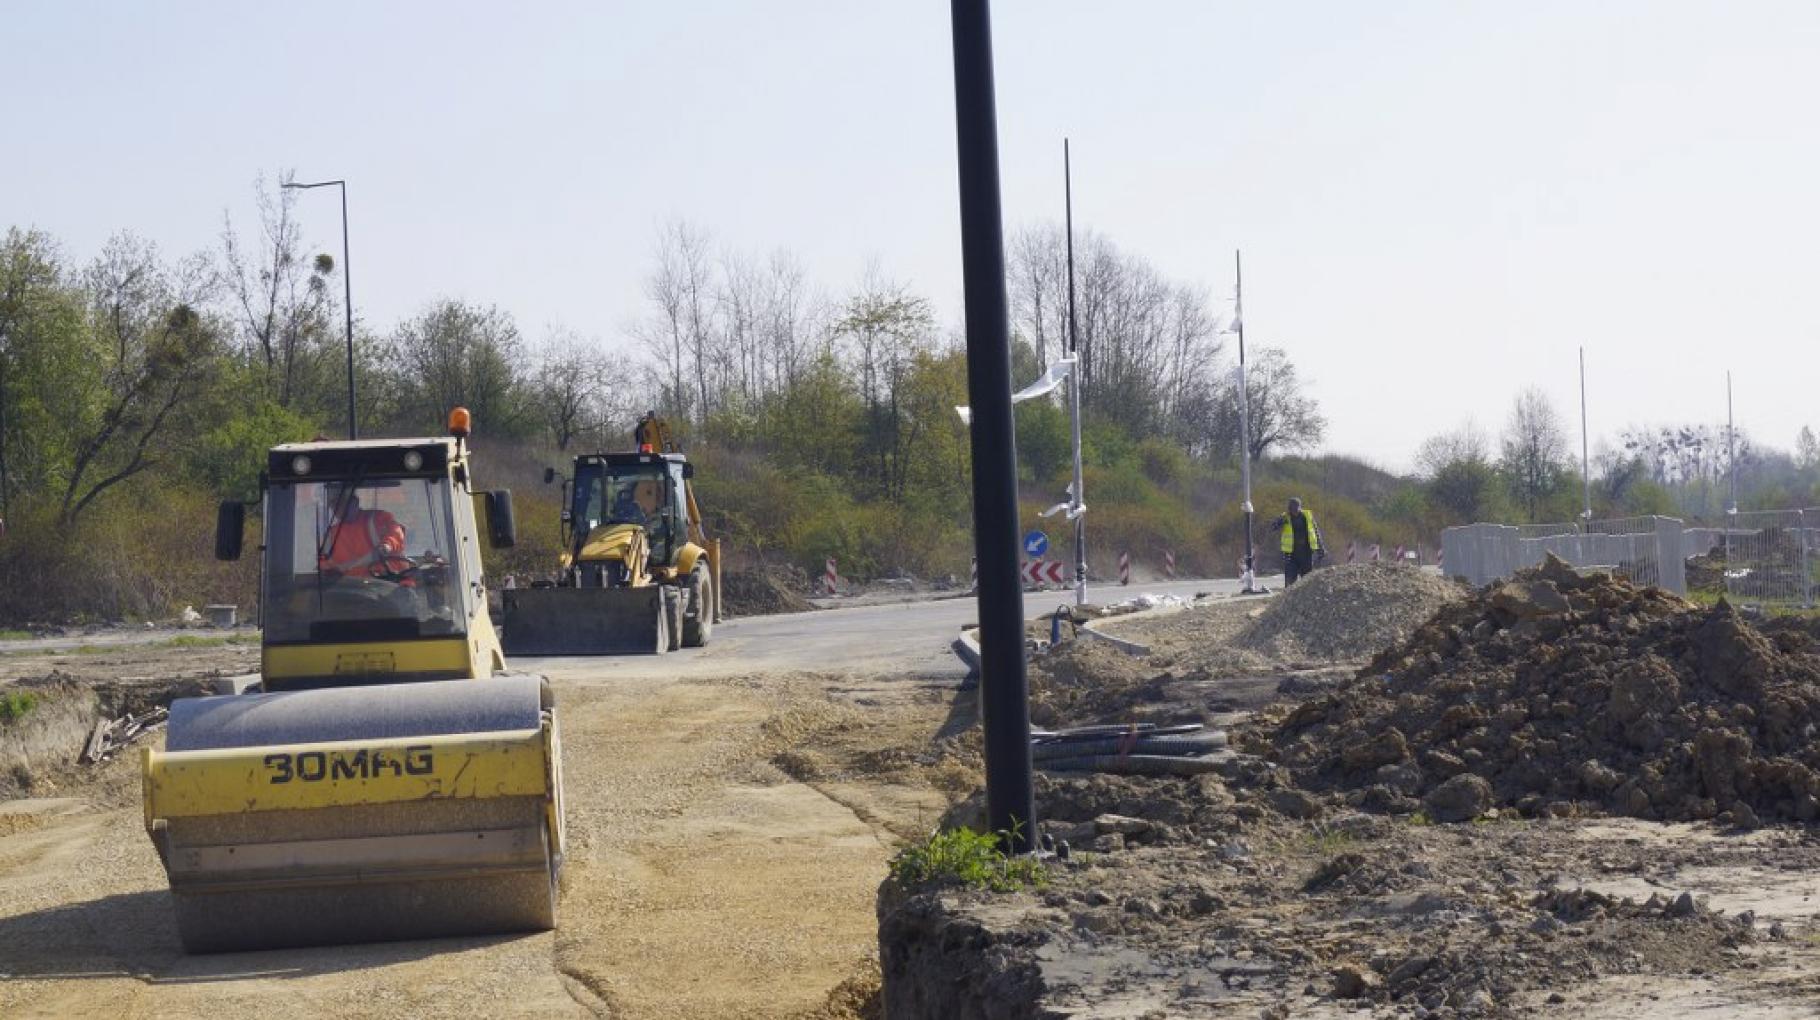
501;585;670;656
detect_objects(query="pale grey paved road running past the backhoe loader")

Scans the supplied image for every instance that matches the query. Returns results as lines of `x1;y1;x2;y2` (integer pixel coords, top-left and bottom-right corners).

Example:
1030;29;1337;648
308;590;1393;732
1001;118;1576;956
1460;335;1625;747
511;579;1239;683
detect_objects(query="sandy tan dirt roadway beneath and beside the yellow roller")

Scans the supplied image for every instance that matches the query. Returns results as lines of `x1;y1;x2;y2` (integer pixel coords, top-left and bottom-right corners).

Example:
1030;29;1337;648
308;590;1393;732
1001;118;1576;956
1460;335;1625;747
0;605;1011;1018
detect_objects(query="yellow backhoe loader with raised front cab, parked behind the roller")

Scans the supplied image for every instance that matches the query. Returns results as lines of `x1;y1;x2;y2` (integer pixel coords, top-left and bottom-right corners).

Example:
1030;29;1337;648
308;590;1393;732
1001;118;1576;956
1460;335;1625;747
502;413;721;656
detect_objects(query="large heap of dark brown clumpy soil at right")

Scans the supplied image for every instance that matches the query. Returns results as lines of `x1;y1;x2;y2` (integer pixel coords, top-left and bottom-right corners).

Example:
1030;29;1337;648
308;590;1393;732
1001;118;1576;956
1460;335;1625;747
1239;557;1820;827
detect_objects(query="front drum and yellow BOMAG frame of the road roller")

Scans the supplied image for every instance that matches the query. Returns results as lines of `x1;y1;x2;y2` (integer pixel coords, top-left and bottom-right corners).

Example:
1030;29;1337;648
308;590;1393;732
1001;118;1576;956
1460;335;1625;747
144;676;562;953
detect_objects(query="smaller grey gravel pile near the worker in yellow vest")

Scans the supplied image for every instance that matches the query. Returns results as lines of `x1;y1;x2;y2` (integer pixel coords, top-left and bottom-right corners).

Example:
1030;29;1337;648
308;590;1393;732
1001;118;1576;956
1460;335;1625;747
1234;563;1467;659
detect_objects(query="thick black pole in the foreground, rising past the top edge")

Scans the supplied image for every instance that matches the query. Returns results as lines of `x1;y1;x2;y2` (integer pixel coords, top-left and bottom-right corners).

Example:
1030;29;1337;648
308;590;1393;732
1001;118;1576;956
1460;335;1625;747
950;0;1036;852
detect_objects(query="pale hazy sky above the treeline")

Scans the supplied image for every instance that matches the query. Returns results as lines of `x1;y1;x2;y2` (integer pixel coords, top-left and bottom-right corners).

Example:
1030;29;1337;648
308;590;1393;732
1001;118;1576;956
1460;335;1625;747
0;0;1820;466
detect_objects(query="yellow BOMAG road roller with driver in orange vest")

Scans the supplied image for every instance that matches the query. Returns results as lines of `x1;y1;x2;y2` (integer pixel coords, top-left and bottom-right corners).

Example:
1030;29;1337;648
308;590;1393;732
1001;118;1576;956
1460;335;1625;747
144;408;562;953
